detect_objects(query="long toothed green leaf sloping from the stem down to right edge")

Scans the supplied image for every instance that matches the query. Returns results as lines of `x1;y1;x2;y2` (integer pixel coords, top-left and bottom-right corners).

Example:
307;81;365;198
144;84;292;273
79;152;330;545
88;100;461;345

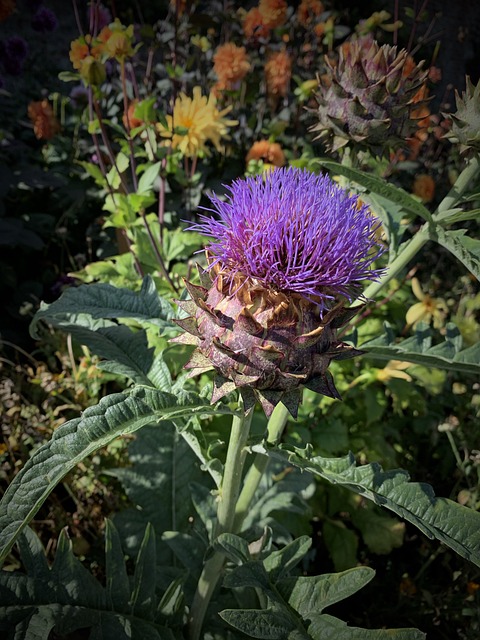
253;445;480;566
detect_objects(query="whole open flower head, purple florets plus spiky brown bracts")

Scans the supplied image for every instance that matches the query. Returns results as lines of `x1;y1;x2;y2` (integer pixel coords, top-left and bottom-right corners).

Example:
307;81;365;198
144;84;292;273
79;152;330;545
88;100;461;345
175;168;381;415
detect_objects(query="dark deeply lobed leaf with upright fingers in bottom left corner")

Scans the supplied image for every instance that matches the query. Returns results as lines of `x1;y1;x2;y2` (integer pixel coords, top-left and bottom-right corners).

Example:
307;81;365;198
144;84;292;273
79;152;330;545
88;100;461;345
0;521;174;640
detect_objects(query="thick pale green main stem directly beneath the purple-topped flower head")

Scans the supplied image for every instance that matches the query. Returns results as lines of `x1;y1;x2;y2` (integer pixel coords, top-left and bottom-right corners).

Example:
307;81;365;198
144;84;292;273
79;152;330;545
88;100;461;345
188;400;253;640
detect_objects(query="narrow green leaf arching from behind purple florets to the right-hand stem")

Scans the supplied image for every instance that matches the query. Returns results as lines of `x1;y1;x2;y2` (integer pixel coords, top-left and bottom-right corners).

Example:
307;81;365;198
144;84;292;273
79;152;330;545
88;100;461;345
318;158;433;223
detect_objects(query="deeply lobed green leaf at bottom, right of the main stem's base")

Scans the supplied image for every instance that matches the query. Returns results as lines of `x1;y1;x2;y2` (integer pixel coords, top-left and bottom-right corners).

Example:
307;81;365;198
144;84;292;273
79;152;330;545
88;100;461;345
216;534;425;640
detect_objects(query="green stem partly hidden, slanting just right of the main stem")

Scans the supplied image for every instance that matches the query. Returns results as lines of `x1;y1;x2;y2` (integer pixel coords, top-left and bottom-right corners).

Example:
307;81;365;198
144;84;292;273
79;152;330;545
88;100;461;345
233;402;289;532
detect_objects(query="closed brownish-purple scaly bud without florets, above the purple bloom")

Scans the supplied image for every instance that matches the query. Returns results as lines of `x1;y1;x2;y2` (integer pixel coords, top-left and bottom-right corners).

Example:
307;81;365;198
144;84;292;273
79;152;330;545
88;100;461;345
311;38;428;156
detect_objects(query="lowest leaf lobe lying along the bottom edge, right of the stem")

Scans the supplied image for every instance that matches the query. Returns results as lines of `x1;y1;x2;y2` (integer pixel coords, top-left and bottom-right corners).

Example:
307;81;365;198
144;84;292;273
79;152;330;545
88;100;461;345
308;613;426;640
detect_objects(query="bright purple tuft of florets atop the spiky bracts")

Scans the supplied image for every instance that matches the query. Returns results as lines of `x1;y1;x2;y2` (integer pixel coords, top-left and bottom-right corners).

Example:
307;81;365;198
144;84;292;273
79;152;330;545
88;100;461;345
191;167;382;308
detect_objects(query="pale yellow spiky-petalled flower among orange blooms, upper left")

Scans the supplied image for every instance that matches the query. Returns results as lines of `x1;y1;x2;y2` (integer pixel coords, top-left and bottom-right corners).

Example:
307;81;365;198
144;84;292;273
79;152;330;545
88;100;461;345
158;87;238;158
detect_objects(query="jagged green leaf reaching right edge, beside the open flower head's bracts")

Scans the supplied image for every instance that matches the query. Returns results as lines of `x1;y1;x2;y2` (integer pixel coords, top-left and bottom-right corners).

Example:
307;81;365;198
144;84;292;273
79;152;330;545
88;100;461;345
360;323;480;375
